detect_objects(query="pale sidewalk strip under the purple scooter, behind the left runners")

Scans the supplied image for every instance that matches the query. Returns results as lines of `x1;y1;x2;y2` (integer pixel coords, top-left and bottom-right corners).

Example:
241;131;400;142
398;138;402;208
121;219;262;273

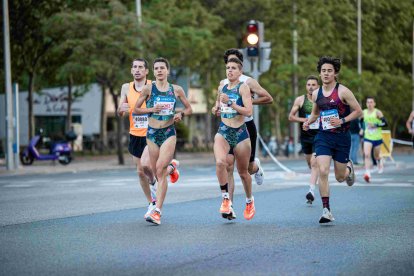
0;152;214;177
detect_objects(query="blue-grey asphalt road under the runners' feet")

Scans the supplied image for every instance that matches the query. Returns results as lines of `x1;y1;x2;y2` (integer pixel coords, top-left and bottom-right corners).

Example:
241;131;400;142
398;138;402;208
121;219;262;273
0;156;414;275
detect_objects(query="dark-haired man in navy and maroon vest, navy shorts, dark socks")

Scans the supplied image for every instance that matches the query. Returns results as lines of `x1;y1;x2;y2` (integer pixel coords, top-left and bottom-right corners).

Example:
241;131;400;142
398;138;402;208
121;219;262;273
303;57;362;223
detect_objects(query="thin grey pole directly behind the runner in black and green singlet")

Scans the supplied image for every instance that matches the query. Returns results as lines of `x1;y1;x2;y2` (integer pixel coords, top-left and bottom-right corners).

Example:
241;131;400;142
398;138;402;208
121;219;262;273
292;1;299;158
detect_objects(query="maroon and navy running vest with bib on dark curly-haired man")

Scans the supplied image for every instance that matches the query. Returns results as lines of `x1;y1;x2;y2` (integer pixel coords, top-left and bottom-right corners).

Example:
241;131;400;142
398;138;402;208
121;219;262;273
316;83;351;132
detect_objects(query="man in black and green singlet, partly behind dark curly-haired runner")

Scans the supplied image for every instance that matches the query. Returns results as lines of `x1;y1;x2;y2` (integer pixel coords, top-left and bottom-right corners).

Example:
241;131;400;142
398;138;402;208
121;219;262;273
289;76;319;204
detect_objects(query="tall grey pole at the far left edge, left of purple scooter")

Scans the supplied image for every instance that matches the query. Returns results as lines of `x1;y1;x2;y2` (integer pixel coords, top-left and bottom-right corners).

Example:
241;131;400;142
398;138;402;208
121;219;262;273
3;0;14;170
